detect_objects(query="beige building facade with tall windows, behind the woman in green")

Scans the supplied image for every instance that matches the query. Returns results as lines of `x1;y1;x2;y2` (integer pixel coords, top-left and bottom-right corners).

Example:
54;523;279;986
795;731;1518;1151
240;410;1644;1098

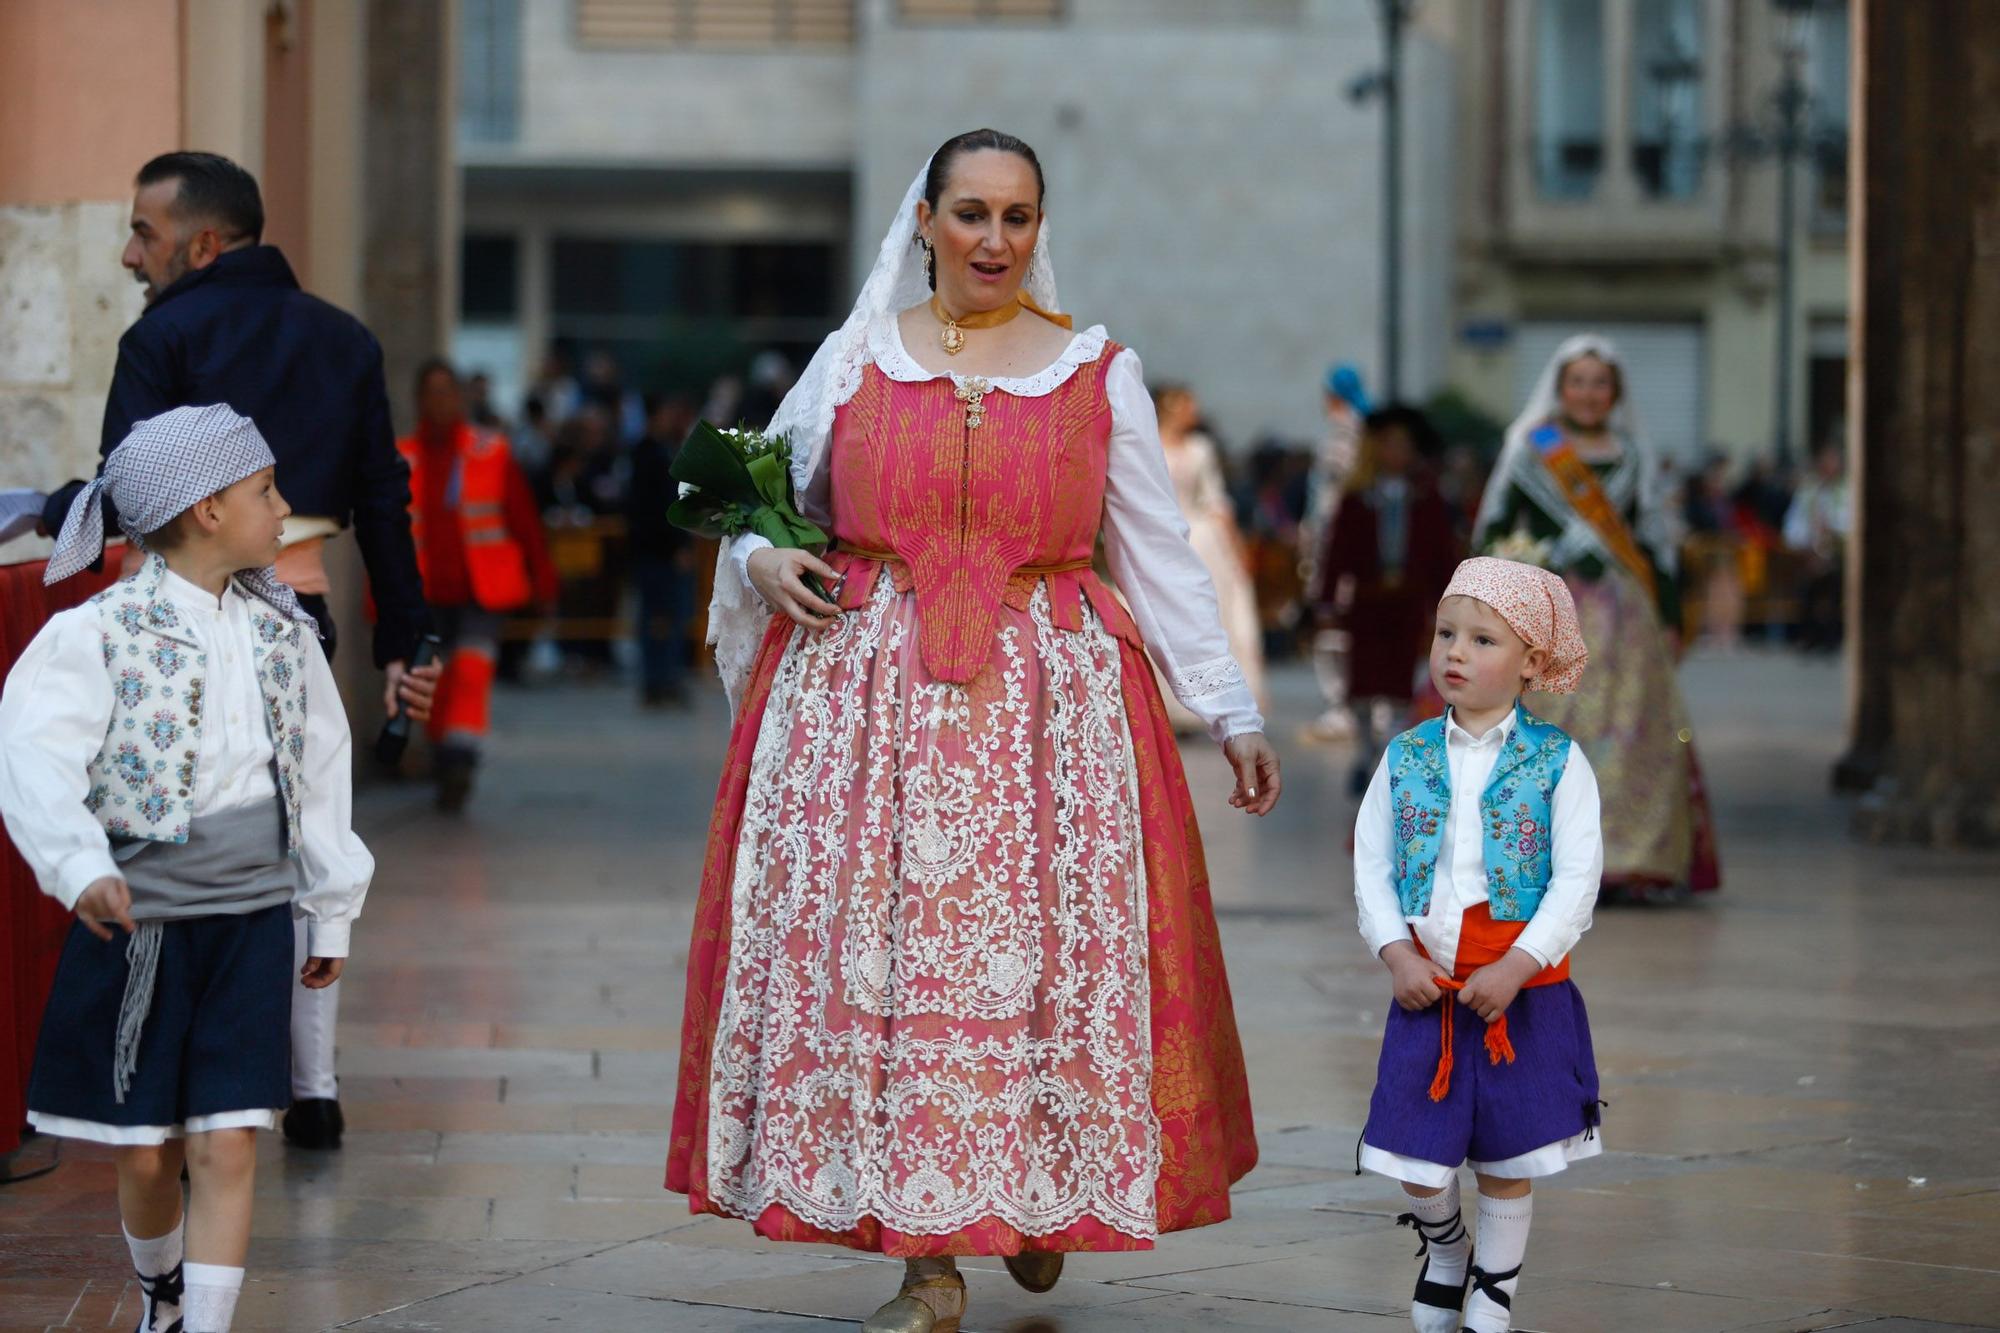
1422;0;1848;464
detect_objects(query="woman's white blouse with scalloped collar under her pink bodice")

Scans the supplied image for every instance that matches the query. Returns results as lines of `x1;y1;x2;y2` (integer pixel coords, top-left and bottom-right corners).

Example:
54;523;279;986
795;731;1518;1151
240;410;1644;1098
730;316;1264;741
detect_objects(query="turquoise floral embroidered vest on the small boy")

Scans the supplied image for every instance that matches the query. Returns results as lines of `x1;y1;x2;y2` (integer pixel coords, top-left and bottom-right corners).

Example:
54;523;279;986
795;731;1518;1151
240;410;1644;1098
1388;705;1570;921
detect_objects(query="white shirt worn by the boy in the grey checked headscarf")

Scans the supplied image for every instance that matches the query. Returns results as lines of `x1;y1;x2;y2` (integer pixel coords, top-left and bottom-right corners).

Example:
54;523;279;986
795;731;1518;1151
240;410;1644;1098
0;570;374;959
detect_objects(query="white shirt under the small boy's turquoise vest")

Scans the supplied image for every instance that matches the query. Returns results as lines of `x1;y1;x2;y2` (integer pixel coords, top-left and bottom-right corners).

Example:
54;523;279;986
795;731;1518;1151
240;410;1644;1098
1354;713;1604;973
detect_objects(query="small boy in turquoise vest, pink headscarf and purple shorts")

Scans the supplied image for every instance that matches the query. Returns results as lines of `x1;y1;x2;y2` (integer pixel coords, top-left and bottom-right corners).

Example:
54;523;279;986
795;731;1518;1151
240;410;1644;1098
1354;558;1604;1333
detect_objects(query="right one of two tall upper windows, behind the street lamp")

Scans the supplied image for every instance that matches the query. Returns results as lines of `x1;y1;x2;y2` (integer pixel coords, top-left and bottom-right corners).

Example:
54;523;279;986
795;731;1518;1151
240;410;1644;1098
1632;0;1702;198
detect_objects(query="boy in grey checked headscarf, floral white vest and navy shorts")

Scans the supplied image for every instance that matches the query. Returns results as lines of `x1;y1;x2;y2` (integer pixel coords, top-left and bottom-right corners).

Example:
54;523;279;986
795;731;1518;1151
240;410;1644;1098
0;406;374;1333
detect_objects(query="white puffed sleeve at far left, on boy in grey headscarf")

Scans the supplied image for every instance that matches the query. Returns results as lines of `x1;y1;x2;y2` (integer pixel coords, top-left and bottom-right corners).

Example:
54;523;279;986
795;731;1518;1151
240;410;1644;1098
0;604;124;911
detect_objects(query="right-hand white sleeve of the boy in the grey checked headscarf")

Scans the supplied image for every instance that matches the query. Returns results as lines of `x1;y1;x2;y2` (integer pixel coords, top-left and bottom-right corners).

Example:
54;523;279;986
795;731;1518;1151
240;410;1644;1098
292;648;374;959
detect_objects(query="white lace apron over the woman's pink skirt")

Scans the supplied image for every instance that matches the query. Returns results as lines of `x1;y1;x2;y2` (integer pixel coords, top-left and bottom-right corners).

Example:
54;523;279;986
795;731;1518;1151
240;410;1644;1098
708;578;1160;1239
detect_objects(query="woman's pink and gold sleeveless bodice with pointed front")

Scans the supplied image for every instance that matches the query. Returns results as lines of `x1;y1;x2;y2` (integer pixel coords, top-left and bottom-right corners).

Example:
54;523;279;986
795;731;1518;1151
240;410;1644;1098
830;340;1138;685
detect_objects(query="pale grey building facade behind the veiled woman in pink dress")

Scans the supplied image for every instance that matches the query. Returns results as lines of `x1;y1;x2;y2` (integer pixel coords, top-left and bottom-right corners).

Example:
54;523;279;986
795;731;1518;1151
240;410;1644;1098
456;0;1454;444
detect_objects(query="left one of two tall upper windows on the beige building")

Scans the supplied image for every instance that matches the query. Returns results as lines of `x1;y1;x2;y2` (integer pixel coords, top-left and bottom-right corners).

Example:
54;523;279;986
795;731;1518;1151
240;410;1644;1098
1534;0;1604;198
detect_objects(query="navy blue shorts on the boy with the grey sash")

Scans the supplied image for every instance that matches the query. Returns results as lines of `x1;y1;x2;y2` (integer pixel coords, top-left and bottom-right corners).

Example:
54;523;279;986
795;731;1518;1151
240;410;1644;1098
28;903;298;1137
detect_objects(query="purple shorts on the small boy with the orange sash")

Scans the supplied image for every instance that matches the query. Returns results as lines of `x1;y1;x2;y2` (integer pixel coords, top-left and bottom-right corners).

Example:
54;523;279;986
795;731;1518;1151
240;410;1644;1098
1362;981;1598;1167
